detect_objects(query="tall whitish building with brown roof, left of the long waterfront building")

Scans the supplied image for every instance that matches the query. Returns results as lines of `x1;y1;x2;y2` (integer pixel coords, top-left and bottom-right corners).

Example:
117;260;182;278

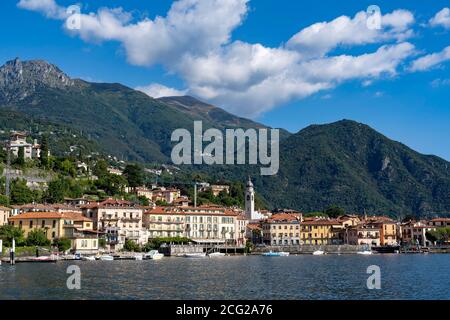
81;199;144;250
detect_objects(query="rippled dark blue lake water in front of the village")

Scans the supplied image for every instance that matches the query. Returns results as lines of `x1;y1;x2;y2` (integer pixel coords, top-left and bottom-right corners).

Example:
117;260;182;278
0;254;450;299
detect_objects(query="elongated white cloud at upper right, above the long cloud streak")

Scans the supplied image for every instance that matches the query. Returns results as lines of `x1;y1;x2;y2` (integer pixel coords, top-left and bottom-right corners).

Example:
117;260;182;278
287;10;414;56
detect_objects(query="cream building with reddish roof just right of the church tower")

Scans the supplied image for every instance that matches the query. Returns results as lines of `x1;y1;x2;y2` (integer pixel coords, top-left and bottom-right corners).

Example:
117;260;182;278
262;213;300;246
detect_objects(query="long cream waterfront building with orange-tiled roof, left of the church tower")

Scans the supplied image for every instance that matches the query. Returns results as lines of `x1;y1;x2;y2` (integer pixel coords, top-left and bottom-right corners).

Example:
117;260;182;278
144;206;246;245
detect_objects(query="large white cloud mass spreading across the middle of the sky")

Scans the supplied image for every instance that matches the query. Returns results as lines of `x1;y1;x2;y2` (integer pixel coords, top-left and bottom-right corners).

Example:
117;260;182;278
17;0;414;117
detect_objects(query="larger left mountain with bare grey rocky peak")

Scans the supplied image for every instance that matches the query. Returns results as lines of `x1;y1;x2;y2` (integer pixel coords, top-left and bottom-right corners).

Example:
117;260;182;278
0;59;274;162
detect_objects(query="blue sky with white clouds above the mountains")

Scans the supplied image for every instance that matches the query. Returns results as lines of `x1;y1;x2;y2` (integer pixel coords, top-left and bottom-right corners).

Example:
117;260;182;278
0;0;450;160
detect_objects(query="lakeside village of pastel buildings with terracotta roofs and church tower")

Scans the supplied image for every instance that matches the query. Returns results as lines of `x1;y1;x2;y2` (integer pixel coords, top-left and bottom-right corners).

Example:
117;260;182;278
0;133;450;259
